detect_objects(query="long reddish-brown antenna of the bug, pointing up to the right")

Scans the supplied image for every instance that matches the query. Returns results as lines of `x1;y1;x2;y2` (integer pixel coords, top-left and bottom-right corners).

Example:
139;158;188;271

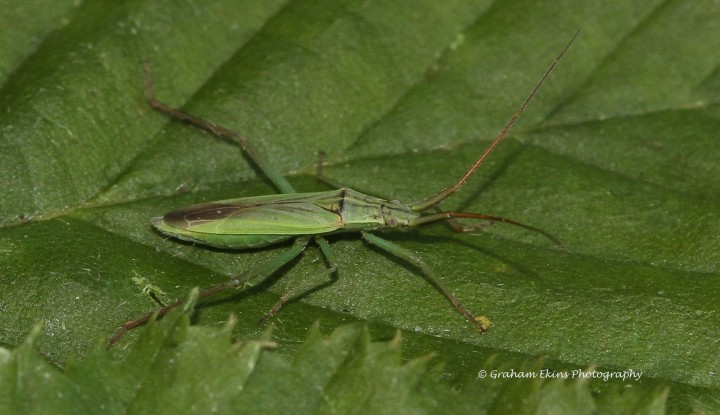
409;27;582;211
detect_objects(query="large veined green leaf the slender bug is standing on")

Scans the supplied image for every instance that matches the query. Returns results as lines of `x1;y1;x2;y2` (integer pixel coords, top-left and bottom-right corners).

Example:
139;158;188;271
0;0;720;413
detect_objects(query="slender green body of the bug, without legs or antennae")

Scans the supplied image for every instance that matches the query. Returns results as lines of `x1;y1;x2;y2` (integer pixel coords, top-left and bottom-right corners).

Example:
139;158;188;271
152;188;421;249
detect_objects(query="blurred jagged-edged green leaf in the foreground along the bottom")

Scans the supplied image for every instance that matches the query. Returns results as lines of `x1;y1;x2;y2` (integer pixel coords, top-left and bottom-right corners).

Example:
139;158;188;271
0;300;667;414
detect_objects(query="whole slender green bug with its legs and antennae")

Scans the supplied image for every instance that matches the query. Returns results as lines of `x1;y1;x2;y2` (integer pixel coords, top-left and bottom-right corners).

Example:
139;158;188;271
108;29;580;346
